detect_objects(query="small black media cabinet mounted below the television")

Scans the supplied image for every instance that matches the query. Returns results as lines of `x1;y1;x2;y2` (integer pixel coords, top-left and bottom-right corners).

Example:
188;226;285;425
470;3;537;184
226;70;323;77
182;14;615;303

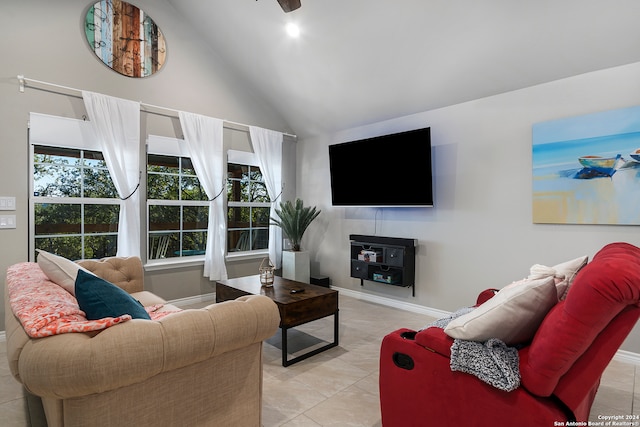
349;234;416;296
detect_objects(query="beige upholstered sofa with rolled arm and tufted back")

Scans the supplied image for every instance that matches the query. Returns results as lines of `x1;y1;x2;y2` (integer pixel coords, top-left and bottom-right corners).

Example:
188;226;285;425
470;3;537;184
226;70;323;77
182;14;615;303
5;258;280;427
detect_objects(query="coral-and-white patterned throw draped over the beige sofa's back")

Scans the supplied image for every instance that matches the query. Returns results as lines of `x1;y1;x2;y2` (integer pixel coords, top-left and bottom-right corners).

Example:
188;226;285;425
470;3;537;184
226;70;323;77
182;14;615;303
7;262;131;338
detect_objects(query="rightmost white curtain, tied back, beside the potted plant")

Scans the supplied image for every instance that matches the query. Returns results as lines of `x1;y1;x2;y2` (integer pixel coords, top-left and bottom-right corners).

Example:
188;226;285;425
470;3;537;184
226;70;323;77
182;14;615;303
249;126;283;268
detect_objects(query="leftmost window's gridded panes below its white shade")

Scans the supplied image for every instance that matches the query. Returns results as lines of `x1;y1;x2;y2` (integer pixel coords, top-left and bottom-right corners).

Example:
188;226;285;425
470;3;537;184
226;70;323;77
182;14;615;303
31;145;120;259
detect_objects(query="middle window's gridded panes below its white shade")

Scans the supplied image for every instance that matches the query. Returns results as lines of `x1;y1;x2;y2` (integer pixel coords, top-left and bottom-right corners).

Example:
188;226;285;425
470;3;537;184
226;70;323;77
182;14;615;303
147;154;209;260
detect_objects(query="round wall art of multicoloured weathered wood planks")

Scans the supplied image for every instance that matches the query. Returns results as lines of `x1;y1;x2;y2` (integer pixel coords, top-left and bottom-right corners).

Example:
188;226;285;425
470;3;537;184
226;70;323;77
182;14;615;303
85;0;167;77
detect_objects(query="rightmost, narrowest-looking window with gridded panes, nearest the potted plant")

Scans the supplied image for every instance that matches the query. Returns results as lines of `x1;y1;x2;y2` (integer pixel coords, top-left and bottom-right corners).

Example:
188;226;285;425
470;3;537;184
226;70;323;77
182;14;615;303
227;160;271;253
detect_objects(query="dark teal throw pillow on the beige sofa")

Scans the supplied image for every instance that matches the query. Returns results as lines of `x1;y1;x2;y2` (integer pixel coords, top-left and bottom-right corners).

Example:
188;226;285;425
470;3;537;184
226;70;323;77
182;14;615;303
76;270;151;320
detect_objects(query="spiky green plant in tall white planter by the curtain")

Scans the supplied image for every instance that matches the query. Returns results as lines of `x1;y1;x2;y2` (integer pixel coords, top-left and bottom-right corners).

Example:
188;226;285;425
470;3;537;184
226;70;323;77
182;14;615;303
271;199;321;283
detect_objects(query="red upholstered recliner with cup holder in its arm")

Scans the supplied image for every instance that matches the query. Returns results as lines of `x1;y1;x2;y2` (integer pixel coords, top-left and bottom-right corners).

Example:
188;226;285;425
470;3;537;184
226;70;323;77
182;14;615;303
380;243;640;427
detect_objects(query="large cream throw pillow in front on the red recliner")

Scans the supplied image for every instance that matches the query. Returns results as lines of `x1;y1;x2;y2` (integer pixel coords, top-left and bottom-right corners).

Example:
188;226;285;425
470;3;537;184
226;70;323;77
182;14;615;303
444;277;558;345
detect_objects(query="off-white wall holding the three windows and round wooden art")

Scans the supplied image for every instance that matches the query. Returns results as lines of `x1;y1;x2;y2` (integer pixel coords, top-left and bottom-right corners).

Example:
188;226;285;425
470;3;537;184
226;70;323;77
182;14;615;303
0;0;295;330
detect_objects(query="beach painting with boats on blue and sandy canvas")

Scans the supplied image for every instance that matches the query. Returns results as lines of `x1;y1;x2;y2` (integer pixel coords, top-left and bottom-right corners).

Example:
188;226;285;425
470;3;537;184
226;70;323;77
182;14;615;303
533;106;640;225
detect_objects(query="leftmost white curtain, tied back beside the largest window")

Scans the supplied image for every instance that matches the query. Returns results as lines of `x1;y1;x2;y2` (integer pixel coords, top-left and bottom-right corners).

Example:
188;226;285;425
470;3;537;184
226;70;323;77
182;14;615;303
82;91;141;257
